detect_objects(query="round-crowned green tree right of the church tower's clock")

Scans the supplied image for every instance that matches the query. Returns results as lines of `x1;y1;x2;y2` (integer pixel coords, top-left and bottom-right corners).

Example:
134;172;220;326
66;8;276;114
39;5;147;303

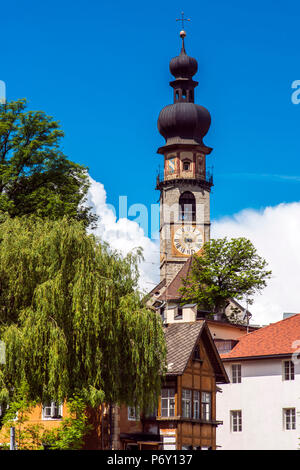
181;238;271;313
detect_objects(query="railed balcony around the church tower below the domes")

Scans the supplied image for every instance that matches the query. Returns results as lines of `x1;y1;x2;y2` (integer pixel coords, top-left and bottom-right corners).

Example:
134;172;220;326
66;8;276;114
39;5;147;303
155;168;213;190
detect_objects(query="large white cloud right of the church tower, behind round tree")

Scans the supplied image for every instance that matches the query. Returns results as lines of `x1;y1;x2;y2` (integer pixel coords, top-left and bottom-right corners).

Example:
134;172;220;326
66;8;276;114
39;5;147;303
212;202;300;324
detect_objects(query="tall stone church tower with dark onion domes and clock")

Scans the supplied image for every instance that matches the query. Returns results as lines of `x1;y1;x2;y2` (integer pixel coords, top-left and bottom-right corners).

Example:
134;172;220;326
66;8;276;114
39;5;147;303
156;30;213;285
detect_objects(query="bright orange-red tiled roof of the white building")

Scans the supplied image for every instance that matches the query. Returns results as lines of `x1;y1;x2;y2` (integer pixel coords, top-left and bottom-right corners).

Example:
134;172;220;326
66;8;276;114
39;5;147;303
221;313;300;360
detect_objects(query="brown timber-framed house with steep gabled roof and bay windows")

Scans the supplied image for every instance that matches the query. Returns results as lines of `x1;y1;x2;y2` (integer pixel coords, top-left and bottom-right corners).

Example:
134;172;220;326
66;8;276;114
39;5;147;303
120;322;228;450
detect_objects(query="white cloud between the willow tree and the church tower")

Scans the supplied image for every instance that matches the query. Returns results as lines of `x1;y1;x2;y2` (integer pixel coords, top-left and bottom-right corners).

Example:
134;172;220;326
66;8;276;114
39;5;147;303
87;178;159;292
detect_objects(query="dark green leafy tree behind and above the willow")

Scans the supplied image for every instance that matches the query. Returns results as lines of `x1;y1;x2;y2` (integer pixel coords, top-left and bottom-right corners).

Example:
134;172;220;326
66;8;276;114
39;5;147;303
0;99;95;225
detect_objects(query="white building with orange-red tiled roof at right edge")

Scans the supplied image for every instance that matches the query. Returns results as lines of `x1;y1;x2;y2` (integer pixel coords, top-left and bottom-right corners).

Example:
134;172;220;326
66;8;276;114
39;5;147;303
217;314;300;450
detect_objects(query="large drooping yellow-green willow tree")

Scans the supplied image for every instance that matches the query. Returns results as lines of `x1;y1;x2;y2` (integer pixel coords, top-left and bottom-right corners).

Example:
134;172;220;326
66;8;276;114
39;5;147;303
0;217;165;409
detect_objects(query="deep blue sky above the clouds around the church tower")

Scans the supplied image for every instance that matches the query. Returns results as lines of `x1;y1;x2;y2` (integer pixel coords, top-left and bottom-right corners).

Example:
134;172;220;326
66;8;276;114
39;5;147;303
0;0;300;222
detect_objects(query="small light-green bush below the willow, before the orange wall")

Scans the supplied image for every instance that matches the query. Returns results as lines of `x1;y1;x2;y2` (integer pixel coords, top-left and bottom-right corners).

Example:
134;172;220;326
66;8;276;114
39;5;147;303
42;396;92;450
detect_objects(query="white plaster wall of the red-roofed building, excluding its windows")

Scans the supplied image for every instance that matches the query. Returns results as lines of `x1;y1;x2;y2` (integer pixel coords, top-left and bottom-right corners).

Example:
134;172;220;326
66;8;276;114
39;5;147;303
217;359;300;450
